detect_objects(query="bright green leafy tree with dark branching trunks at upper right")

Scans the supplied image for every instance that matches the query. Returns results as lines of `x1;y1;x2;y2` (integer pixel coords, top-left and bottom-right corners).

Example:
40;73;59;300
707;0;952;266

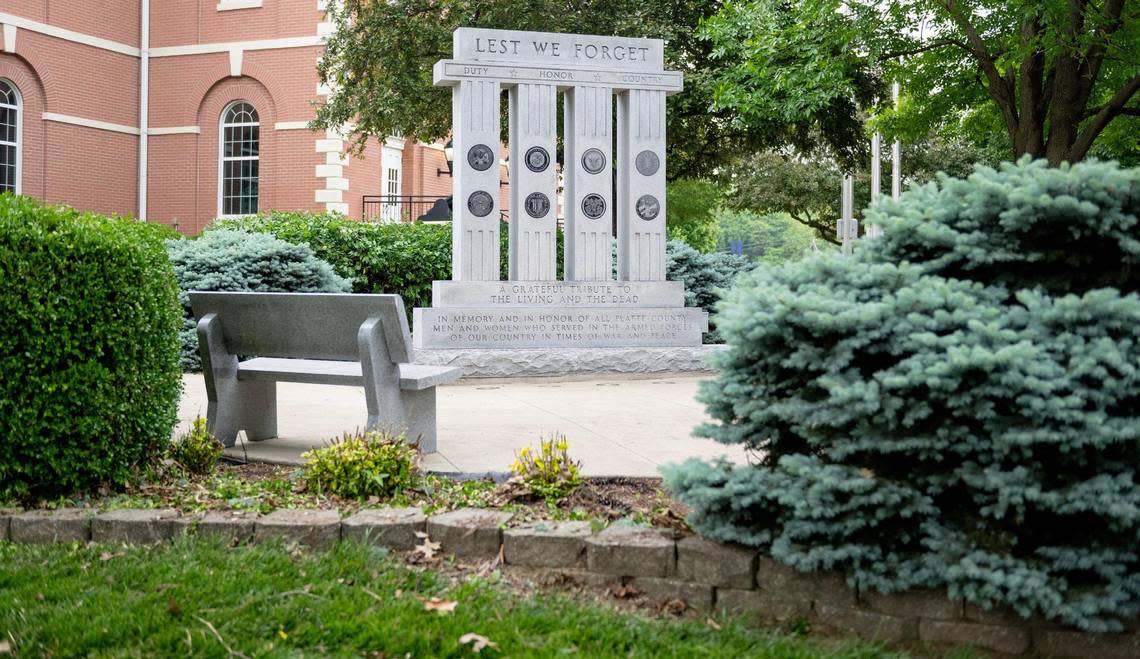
702;0;1140;165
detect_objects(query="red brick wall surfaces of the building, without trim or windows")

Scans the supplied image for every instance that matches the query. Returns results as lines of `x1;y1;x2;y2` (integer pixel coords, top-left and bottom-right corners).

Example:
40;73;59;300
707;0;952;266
0;0;481;234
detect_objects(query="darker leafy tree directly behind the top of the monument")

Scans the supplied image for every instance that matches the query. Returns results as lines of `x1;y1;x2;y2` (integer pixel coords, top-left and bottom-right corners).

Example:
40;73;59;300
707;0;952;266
314;0;875;180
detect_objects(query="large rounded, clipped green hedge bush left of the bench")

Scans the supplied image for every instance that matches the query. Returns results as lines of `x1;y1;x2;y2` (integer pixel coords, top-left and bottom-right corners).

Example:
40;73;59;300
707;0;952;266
0;194;181;498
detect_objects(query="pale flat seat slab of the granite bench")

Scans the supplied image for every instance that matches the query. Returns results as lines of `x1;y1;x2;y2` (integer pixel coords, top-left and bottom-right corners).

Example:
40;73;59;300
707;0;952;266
237;357;463;391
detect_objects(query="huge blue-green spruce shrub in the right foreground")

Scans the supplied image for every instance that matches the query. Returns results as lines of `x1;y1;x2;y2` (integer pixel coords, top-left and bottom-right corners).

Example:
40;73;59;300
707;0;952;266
667;160;1140;630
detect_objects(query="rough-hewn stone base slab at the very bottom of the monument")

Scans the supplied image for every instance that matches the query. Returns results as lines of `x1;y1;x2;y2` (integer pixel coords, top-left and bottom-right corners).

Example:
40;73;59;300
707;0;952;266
416;345;724;377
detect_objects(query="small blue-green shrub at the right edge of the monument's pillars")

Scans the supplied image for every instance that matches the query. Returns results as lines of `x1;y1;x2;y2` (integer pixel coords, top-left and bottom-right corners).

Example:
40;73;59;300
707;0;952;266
665;241;752;343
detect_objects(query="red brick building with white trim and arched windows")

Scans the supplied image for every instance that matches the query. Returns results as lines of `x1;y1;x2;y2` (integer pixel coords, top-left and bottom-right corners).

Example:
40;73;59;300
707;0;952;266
0;0;476;234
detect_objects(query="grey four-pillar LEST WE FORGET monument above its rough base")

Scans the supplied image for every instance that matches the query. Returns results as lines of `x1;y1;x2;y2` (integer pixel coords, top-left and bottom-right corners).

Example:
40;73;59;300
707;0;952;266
414;27;708;360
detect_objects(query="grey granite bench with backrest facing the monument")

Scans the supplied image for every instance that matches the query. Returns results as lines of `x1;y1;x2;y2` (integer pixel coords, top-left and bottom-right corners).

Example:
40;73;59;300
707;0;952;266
190;292;463;453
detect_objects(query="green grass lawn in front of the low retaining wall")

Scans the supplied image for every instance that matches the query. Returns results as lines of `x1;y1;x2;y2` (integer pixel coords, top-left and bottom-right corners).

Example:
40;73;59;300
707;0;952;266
0;538;898;659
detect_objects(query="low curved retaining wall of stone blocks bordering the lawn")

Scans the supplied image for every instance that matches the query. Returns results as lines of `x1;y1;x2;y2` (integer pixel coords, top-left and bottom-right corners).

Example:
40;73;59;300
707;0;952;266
0;509;1140;659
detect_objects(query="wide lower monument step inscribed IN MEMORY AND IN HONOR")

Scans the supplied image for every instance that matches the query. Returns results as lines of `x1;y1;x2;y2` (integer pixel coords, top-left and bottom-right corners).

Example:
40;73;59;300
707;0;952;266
415;307;708;349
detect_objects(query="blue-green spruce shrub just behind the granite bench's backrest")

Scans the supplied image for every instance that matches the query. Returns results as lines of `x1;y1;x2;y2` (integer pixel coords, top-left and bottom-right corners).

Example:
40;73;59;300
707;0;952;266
166;230;351;371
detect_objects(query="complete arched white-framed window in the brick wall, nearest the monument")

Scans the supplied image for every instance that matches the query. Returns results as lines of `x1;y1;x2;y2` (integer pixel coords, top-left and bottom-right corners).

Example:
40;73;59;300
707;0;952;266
218;100;261;215
